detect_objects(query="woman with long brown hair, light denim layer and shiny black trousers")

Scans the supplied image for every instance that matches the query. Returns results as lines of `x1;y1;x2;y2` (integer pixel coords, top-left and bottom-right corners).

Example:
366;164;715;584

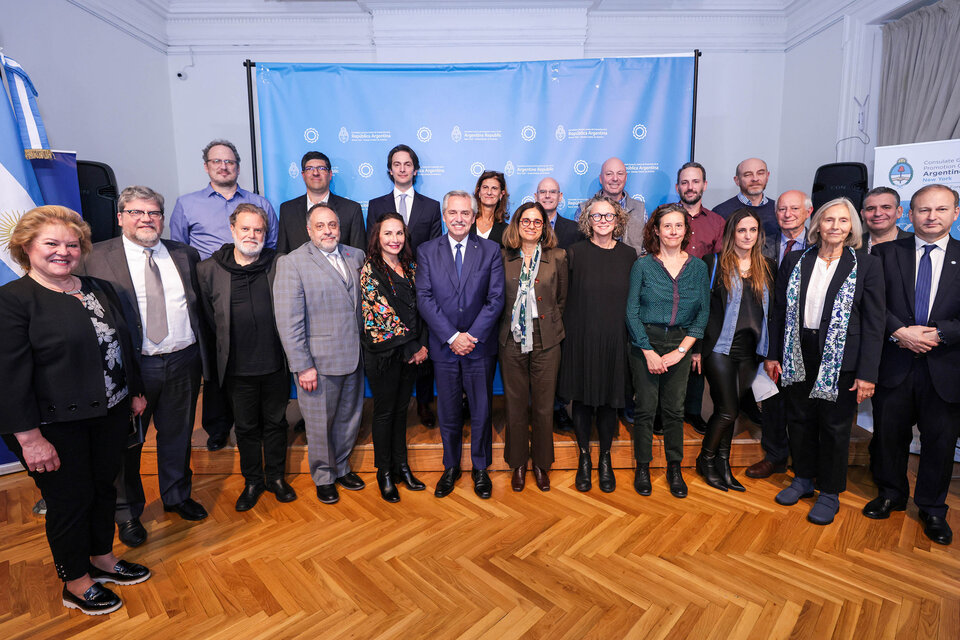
697;208;776;491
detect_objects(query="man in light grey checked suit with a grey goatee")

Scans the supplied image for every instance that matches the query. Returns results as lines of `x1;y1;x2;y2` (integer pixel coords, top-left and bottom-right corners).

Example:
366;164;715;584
273;204;364;504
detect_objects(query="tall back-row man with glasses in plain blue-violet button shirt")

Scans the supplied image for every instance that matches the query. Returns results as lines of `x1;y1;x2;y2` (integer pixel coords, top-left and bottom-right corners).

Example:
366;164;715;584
170;140;277;260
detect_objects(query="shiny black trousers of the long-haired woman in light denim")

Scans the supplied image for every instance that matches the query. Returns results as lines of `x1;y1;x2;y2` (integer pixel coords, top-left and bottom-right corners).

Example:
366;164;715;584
702;335;757;455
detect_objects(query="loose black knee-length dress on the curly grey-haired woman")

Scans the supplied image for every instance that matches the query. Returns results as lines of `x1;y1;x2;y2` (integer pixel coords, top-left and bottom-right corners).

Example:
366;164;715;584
558;240;637;409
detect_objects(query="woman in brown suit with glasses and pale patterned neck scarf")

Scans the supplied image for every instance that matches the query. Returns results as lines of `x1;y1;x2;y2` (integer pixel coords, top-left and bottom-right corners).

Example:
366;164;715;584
500;202;567;491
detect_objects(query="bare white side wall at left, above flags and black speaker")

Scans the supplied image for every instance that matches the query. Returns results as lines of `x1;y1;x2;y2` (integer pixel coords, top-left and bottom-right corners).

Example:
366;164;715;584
0;0;179;206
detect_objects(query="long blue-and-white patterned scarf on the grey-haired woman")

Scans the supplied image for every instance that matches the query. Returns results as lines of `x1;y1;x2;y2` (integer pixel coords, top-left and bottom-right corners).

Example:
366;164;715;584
782;245;857;402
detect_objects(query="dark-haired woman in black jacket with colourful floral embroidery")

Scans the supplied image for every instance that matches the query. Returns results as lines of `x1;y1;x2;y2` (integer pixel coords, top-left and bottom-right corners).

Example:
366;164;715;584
360;213;427;502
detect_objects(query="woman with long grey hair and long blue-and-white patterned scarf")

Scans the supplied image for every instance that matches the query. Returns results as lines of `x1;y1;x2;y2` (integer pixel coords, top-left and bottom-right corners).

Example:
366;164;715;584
764;198;886;525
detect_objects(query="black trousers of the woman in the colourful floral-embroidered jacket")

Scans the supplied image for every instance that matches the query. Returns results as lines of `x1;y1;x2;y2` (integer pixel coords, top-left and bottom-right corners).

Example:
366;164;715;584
363;351;416;471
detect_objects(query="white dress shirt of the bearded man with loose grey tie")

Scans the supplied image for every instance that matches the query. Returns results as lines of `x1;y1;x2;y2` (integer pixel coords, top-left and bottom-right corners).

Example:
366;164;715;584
122;236;197;356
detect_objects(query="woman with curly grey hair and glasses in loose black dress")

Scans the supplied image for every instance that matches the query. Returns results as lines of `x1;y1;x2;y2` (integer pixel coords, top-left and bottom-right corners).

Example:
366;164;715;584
559;196;637;493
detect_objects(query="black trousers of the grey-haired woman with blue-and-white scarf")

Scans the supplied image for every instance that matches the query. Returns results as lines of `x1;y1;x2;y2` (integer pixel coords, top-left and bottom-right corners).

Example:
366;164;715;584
786;329;857;493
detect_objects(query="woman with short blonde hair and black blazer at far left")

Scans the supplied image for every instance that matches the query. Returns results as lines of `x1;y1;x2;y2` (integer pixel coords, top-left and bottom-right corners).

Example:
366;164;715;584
0;206;150;615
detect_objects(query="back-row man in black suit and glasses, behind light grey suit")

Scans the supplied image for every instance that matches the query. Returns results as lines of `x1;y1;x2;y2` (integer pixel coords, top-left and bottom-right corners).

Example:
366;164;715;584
277;151;367;254
